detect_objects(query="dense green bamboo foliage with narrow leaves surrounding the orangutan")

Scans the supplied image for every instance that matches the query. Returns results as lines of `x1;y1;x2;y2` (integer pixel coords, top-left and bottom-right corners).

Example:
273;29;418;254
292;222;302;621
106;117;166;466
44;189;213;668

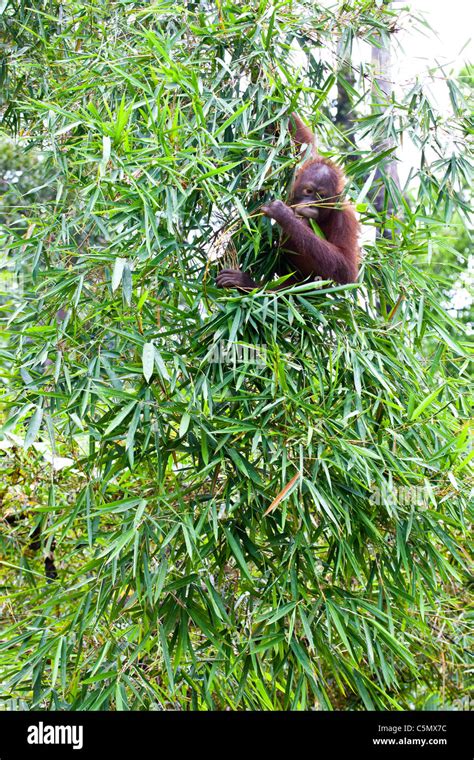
0;0;472;710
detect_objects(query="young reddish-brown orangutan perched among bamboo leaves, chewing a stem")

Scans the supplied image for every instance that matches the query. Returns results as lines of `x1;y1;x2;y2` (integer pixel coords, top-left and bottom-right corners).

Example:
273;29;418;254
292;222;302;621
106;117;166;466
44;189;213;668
217;114;359;290
